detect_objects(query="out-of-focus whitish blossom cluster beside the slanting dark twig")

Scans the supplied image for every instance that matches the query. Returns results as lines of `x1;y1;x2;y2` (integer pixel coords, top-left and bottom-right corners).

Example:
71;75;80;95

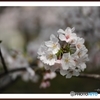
2;47;39;83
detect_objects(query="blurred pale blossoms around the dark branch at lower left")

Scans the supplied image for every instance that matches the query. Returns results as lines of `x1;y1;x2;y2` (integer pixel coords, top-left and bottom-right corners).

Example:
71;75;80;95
4;47;35;81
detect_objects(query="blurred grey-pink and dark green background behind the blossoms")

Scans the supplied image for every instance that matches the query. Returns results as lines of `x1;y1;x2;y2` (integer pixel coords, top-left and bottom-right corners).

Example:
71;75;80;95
0;7;100;93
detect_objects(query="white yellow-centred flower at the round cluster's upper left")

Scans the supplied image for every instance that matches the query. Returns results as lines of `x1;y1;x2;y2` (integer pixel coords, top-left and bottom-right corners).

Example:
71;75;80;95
45;34;60;54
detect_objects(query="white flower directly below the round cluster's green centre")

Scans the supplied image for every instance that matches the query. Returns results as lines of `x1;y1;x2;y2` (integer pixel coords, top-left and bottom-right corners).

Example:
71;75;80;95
61;53;75;70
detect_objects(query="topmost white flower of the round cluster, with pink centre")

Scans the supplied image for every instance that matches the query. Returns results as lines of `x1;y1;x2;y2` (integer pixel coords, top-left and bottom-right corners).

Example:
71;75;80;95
58;27;77;43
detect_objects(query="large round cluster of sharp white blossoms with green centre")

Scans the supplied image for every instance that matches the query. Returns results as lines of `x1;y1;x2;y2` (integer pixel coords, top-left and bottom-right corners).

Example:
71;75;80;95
37;27;89;78
